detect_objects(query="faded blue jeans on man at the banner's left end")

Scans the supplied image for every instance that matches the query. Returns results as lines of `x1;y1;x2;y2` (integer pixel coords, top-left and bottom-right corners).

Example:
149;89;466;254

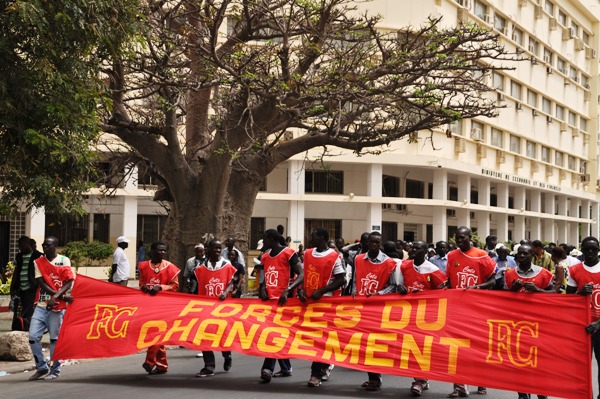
29;306;65;375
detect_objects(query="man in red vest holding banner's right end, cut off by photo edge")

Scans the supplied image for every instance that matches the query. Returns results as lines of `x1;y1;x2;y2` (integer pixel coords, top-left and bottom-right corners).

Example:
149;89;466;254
567;237;600;398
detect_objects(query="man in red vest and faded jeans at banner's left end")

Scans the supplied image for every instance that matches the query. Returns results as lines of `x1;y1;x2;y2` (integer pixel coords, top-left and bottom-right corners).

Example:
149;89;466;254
29;236;75;381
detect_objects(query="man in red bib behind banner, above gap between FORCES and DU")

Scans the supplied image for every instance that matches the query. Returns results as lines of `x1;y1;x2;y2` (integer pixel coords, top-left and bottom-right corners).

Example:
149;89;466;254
352;231;400;391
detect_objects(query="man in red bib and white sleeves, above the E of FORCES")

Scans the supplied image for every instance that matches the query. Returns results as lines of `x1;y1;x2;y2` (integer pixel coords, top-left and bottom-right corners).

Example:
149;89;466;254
299;228;346;387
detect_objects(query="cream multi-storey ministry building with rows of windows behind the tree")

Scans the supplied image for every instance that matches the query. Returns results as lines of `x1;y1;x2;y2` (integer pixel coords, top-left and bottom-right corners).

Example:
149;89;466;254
0;0;600;272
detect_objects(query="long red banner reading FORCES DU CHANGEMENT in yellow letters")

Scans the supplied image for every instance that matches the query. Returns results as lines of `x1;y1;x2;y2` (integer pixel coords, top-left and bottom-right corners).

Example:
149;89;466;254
54;276;592;399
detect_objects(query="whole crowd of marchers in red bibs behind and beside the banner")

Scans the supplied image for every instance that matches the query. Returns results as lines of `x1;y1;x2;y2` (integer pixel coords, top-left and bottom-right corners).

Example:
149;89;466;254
11;226;600;399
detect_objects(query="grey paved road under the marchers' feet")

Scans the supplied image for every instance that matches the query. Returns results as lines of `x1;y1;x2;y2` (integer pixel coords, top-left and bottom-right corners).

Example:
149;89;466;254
0;349;597;399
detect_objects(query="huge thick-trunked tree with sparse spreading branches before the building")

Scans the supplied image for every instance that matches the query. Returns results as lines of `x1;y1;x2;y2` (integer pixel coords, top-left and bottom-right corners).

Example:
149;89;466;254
0;0;513;268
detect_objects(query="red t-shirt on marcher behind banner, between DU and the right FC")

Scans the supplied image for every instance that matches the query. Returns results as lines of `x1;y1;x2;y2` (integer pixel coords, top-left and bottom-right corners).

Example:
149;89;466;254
446;247;496;288
